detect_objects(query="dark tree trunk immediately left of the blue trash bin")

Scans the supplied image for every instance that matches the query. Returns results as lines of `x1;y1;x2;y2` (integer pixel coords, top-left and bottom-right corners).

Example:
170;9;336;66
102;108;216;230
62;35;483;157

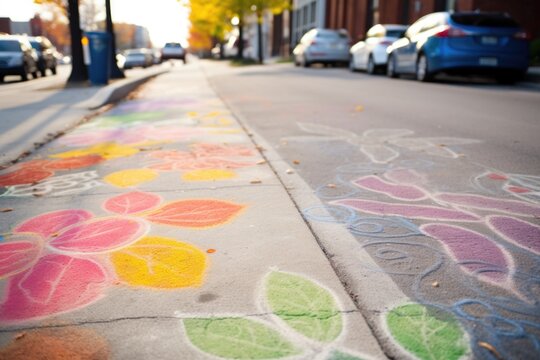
68;0;88;83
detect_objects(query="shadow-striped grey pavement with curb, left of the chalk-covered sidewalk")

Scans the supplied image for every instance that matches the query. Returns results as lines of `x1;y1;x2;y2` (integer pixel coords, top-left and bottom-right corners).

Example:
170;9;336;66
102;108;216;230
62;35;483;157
0;65;169;165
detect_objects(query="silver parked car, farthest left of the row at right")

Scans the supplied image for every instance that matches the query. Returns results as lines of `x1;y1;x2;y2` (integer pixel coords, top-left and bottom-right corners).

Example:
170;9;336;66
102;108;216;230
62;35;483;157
293;28;350;67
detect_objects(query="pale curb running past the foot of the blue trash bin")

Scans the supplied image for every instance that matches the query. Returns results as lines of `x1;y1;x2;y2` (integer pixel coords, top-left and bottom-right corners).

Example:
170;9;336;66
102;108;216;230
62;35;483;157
77;69;170;110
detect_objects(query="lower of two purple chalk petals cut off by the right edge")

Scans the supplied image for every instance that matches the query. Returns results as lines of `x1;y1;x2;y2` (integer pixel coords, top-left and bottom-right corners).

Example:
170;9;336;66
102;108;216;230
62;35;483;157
486;216;540;255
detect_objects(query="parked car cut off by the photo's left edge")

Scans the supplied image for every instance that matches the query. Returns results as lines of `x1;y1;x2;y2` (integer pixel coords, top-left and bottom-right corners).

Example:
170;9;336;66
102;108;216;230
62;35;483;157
0;35;38;82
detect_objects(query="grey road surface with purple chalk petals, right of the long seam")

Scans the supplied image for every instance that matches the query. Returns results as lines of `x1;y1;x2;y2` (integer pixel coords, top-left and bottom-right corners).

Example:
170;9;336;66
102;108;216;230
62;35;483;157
209;63;540;359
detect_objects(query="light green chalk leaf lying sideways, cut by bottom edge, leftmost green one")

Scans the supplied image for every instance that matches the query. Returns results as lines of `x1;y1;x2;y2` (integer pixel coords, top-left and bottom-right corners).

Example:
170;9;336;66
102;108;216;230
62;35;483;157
184;318;301;359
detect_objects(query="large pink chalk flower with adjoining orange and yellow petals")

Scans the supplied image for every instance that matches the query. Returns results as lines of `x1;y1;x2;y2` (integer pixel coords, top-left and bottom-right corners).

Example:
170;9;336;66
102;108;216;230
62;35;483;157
0;191;245;323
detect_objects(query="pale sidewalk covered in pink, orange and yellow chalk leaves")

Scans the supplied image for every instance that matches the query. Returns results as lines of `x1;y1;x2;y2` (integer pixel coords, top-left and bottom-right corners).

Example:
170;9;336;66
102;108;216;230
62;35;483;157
0;63;385;359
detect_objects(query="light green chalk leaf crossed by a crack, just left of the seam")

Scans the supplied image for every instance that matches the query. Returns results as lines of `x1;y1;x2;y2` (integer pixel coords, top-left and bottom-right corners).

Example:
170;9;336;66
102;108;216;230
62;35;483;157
266;271;343;342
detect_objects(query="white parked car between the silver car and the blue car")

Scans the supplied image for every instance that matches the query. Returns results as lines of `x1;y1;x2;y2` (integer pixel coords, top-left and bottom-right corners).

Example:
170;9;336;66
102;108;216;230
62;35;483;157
349;24;407;74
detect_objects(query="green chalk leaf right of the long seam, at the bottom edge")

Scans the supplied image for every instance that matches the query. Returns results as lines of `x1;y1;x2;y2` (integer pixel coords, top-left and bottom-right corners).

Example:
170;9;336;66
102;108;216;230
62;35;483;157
386;304;468;360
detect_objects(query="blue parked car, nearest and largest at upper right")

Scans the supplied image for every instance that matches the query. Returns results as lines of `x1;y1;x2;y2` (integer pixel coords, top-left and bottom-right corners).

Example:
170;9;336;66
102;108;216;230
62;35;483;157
387;12;529;83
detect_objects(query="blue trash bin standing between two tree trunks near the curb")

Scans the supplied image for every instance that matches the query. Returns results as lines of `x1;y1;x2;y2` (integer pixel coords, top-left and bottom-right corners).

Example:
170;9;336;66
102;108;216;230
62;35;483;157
85;31;112;85
